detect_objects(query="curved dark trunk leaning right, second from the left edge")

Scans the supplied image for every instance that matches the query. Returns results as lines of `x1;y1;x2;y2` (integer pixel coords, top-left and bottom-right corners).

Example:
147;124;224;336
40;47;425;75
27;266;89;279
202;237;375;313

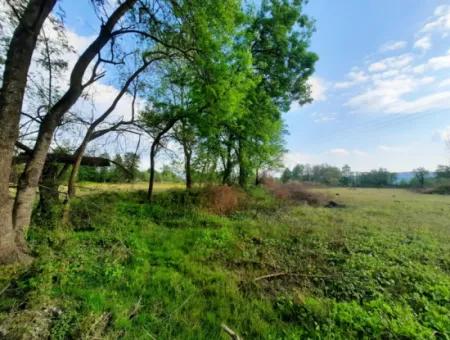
13;0;137;239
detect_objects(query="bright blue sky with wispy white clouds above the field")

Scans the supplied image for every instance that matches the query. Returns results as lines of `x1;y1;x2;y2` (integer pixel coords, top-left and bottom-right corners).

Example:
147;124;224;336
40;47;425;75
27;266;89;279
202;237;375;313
58;0;450;171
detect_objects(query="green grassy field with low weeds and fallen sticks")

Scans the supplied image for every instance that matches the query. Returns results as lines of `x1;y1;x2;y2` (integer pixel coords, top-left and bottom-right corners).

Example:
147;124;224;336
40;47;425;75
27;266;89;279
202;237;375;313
0;185;450;339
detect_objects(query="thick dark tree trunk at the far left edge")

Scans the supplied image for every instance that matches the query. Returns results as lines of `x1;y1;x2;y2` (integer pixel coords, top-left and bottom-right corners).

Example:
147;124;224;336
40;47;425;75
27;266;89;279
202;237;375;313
0;0;56;263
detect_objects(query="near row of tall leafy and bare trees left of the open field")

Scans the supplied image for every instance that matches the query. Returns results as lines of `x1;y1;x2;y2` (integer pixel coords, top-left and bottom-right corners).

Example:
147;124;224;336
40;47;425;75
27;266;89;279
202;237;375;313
0;0;318;263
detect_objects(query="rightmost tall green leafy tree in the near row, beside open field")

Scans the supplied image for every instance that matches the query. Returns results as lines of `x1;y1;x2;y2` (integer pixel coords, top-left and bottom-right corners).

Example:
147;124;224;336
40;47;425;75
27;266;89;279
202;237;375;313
236;0;318;186
